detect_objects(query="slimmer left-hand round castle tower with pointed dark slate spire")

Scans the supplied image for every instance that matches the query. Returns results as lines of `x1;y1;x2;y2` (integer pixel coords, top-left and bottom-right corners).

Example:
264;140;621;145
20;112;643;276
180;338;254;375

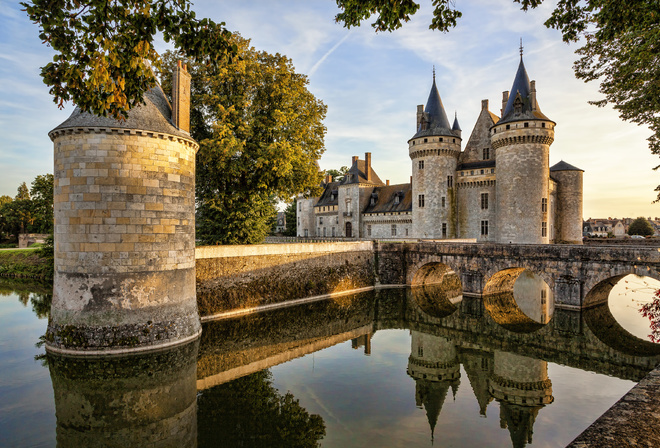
408;72;461;238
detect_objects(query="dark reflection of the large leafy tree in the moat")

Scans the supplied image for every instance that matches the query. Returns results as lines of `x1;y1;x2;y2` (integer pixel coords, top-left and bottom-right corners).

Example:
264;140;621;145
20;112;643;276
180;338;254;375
197;370;325;448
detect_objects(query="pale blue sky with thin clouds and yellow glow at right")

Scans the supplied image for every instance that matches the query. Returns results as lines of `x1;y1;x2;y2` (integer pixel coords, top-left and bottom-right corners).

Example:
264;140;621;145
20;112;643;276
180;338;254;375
0;0;660;219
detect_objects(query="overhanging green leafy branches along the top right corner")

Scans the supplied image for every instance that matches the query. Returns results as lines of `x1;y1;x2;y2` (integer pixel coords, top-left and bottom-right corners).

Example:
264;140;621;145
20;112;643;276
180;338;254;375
335;0;660;198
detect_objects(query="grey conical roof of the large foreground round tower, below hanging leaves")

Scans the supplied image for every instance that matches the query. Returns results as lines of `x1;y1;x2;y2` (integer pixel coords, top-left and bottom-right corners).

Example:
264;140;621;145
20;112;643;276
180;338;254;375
51;86;190;139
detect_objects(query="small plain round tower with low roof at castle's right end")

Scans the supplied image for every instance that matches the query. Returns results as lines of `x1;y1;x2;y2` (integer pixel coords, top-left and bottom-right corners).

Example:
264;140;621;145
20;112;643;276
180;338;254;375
550;160;584;244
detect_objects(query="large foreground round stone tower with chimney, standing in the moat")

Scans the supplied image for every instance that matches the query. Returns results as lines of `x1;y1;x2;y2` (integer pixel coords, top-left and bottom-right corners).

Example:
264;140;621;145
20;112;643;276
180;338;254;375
46;65;201;354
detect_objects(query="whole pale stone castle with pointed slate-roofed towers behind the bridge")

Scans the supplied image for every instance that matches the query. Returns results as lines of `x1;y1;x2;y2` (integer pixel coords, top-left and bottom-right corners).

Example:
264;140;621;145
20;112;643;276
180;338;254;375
297;54;583;244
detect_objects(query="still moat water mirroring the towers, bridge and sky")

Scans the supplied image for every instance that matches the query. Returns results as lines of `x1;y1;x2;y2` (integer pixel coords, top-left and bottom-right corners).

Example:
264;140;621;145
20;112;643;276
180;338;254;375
0;272;660;448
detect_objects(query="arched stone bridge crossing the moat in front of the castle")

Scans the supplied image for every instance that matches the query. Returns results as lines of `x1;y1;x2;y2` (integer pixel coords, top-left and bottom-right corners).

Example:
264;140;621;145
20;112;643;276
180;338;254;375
374;241;660;309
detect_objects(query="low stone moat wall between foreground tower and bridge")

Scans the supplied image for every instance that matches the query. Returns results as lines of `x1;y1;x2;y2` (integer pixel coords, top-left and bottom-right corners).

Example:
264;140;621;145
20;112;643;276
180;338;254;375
196;241;376;317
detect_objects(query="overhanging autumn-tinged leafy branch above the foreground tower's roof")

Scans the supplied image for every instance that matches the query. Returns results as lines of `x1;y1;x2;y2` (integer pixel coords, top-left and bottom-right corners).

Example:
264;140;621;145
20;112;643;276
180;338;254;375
21;0;235;119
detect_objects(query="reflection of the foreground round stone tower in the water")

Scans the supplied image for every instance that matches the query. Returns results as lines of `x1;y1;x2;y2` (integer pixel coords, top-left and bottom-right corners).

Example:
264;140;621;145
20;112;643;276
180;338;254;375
48;341;199;448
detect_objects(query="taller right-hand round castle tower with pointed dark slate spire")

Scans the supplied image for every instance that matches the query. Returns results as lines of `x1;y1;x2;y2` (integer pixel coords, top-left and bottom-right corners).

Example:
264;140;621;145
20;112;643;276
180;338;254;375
490;55;555;244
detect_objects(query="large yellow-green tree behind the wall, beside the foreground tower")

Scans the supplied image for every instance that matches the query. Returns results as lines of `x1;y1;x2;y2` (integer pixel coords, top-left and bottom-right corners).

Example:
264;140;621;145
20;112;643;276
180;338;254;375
161;35;326;244
